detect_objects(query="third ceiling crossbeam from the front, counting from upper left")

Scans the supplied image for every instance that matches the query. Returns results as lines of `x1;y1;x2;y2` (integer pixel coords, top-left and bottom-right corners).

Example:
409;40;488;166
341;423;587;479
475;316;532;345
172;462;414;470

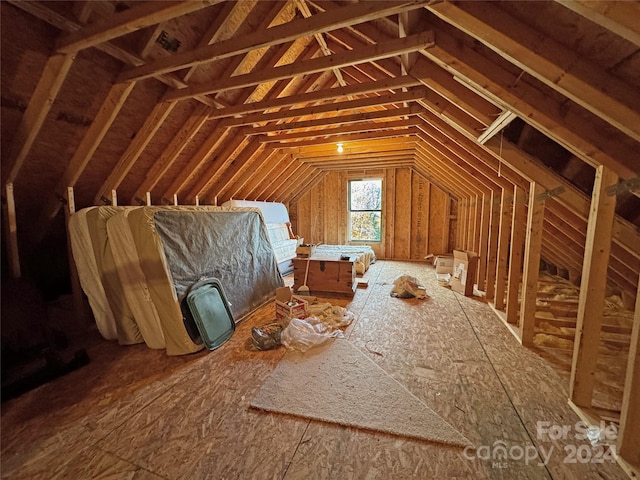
165;31;434;101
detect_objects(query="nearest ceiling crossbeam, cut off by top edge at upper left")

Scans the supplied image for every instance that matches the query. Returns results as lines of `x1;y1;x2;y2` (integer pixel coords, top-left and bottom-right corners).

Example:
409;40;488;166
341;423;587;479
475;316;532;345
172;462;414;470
56;0;222;53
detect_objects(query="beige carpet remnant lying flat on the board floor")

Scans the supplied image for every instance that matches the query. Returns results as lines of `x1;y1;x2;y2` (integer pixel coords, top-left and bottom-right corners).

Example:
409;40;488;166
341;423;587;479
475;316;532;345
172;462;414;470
251;339;471;446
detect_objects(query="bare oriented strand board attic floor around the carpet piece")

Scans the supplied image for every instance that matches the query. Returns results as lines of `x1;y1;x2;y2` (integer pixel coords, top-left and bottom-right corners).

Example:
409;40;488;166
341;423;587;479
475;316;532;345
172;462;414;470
1;261;627;480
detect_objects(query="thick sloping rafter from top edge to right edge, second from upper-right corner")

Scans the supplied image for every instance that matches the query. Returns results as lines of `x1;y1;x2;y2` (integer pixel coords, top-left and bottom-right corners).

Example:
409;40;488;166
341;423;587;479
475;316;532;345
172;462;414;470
426;2;640;141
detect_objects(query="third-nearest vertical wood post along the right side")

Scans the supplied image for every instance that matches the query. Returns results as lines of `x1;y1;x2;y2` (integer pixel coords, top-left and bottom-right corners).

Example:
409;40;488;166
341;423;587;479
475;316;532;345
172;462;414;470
520;182;545;347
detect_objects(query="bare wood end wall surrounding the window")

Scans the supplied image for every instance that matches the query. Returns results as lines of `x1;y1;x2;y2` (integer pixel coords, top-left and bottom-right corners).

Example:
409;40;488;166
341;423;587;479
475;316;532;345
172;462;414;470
289;167;453;260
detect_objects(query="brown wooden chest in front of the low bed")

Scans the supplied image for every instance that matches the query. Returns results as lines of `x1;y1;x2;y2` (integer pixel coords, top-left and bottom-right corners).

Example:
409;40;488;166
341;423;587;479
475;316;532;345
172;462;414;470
293;255;357;296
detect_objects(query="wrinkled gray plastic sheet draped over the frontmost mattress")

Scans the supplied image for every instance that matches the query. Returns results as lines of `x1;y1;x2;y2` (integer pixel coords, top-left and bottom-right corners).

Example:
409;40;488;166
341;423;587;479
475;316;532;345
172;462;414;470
154;210;284;320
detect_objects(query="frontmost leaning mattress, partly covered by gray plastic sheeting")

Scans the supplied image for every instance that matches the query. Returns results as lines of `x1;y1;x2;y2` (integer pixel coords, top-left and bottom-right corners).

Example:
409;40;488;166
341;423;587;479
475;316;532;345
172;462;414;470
127;207;283;355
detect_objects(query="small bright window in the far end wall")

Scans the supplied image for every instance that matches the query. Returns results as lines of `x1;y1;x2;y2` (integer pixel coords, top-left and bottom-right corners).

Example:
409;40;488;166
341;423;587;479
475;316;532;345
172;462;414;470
349;179;382;242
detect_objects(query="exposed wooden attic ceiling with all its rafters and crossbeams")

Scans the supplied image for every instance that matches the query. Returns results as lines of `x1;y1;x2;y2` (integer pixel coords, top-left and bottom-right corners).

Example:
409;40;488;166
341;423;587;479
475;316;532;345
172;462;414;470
0;0;640;291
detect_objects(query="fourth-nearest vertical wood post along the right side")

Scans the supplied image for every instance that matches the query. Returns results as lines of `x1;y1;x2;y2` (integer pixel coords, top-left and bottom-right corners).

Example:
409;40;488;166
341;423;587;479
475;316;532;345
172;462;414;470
507;186;527;324
